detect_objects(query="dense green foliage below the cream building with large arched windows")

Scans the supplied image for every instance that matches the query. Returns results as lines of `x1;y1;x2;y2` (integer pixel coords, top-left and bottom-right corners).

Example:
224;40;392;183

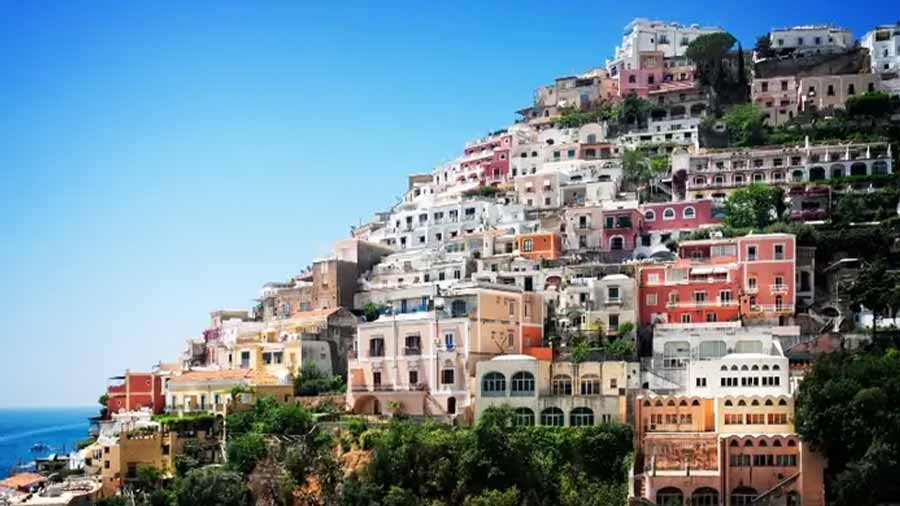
341;408;632;506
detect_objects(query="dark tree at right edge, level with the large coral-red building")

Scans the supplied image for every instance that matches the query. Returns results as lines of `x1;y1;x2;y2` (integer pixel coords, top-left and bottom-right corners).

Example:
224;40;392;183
844;258;900;340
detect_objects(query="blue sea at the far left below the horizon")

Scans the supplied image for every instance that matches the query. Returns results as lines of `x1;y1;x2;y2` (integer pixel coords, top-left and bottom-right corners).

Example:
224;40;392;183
0;407;98;479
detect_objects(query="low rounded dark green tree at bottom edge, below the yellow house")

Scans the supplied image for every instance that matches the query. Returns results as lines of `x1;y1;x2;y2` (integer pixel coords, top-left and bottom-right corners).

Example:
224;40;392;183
175;466;247;506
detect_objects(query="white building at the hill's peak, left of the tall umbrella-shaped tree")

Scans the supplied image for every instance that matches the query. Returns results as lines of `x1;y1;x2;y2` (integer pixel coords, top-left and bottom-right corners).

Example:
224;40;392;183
606;18;724;76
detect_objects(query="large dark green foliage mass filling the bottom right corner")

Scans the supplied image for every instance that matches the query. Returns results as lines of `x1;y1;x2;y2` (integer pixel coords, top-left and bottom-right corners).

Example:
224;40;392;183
797;349;900;506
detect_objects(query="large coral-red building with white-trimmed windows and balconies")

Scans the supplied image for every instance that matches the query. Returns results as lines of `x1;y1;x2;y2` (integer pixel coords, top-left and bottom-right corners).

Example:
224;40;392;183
638;234;796;325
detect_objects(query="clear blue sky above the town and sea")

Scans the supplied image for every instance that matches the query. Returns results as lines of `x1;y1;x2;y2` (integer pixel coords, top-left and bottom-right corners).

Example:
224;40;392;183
0;0;888;406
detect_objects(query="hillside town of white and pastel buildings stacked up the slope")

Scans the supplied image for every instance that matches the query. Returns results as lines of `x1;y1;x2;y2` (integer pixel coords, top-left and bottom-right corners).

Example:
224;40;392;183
0;18;900;506
